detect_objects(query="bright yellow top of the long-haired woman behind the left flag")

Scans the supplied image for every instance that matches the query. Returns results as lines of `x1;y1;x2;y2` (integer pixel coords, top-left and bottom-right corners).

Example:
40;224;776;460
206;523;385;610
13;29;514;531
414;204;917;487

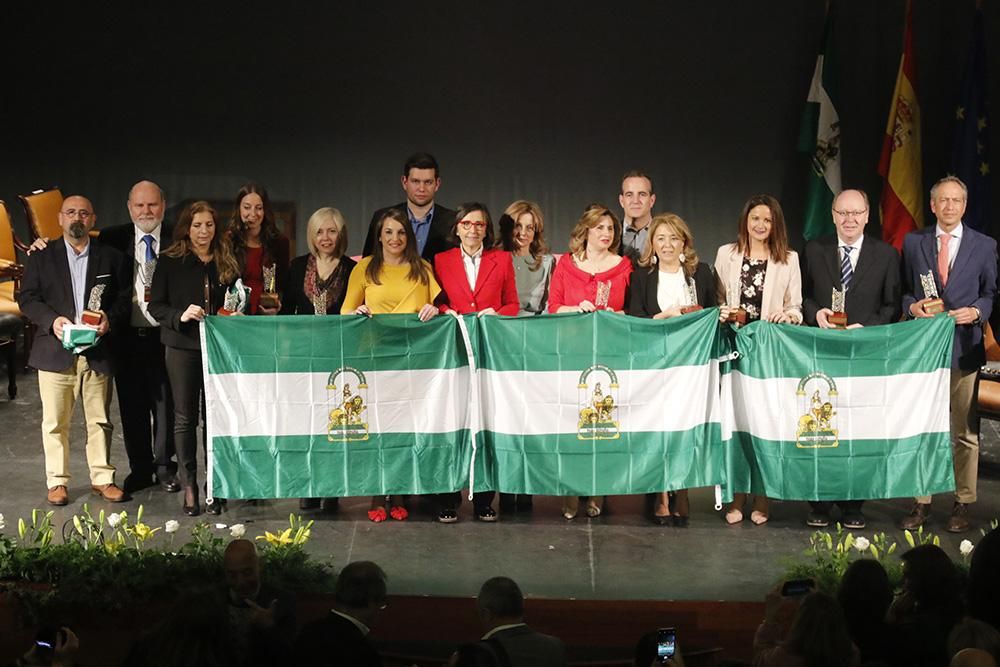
340;257;441;315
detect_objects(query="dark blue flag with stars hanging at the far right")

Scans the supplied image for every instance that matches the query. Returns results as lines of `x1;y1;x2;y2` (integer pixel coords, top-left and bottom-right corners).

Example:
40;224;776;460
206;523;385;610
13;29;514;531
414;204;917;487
951;9;994;234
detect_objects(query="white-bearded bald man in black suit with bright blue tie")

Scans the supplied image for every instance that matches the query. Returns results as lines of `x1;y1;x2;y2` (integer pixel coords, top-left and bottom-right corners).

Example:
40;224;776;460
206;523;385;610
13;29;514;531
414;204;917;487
100;181;180;493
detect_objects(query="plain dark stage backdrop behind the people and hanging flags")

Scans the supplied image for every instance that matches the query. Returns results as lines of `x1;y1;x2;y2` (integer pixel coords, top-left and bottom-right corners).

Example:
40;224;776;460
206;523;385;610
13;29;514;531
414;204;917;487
0;0;1000;258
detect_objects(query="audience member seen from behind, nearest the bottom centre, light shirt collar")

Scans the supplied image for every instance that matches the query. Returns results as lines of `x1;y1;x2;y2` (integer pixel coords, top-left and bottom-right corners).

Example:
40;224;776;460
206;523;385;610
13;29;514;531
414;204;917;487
476;577;566;667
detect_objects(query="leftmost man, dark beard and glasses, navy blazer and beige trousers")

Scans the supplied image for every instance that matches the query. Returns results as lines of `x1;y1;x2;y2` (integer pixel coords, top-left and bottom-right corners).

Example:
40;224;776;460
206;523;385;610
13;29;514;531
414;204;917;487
18;195;128;505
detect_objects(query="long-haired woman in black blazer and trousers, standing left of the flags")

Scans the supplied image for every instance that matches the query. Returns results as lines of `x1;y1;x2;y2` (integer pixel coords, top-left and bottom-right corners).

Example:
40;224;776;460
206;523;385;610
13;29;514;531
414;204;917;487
149;201;240;516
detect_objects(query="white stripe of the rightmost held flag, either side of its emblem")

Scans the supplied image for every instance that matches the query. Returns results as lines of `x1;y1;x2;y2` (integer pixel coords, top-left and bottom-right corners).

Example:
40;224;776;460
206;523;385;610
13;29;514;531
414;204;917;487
731;368;951;442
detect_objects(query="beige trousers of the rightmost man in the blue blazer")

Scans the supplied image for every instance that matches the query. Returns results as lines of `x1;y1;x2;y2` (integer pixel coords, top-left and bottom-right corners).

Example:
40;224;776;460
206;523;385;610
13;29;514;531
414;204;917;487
917;368;979;503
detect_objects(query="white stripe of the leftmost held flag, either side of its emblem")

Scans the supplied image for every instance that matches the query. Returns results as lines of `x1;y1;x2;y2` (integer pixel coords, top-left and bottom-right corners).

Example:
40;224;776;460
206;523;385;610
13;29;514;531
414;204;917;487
205;368;469;437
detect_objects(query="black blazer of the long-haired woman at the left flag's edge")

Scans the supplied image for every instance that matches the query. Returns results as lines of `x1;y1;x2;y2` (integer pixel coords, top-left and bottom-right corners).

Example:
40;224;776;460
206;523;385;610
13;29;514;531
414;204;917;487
149;252;226;350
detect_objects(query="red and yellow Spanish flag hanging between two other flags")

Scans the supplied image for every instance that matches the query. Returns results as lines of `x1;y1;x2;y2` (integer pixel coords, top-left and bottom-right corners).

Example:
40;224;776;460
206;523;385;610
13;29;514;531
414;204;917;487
878;0;924;250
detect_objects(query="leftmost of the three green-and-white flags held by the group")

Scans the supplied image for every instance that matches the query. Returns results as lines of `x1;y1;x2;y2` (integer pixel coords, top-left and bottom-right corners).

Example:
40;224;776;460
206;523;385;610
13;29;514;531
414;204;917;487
202;315;471;498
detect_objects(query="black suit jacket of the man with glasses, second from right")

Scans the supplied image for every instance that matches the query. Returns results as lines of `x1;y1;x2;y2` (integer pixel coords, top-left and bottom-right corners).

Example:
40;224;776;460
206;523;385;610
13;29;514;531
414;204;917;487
802;236;900;327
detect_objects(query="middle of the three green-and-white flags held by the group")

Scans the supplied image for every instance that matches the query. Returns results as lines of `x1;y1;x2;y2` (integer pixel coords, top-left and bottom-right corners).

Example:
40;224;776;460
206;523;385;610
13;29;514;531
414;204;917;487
477;308;724;495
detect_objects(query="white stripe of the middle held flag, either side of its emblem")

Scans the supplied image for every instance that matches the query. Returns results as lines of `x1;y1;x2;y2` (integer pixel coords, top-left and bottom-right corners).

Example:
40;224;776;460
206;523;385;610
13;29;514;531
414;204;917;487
480;361;720;435
